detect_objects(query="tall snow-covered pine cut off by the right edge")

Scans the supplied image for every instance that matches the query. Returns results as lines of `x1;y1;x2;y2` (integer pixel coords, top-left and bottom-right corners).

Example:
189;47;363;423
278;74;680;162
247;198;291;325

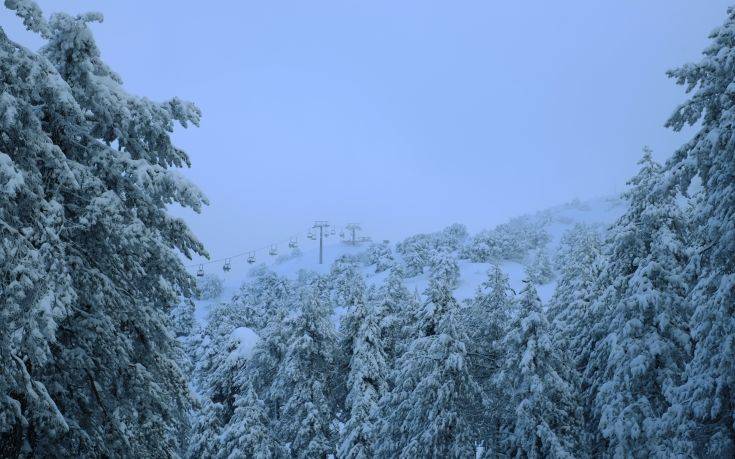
665;7;735;457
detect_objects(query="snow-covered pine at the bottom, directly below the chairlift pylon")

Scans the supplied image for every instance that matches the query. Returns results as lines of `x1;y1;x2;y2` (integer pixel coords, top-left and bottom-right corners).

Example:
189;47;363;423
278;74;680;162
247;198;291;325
272;279;336;458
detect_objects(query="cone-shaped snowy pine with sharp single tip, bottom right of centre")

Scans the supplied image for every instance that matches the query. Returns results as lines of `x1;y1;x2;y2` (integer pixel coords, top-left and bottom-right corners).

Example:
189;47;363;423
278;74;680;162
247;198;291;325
496;278;581;458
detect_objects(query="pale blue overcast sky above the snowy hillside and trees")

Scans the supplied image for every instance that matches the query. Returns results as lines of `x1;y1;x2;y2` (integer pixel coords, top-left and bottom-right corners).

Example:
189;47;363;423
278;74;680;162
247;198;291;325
0;0;727;264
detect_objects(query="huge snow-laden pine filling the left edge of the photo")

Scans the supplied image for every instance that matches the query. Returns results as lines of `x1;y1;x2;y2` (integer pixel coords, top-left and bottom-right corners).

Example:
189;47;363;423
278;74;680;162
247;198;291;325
0;0;205;457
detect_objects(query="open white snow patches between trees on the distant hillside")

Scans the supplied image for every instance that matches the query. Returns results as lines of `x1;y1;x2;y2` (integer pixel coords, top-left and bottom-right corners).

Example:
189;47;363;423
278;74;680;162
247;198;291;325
195;198;625;323
